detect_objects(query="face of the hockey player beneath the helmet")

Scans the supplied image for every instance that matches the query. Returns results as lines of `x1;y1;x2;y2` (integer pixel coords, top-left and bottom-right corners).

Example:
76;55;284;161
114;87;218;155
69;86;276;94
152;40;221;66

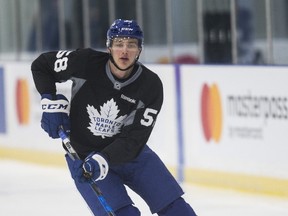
110;38;141;76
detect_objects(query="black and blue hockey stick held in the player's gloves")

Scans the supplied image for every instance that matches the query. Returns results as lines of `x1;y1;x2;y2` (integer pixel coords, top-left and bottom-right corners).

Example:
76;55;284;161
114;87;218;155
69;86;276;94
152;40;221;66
58;127;116;216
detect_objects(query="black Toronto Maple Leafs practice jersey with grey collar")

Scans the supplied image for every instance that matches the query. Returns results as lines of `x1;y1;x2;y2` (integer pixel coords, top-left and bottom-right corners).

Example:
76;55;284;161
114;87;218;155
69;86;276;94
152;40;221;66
31;49;163;164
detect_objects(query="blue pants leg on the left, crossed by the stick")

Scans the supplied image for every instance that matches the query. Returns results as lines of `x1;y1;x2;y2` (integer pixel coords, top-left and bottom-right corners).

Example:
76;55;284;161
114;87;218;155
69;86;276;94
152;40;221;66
66;155;133;216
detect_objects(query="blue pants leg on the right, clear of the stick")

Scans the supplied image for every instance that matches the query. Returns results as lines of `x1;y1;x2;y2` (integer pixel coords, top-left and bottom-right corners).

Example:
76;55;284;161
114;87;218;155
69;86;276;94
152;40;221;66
111;146;183;213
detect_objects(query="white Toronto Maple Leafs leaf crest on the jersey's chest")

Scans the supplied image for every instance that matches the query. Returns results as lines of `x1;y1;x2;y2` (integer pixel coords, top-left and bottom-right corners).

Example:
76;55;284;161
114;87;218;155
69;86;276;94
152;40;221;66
87;98;127;139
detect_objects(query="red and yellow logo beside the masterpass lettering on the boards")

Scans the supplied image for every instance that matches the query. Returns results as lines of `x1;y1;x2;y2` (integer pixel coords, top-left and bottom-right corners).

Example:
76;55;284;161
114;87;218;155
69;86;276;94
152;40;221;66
201;84;223;142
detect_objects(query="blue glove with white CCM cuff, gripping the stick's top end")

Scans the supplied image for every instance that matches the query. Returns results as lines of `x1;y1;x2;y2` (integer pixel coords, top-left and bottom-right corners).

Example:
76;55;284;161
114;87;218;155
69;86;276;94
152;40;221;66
41;94;70;139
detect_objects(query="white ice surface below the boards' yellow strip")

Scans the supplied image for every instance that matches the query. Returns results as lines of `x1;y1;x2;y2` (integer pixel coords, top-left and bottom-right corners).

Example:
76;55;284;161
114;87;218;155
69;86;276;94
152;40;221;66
0;160;288;216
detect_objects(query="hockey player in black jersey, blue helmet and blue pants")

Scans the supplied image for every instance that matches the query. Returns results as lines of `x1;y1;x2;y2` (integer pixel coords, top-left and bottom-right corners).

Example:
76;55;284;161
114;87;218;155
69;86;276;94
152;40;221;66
31;19;196;216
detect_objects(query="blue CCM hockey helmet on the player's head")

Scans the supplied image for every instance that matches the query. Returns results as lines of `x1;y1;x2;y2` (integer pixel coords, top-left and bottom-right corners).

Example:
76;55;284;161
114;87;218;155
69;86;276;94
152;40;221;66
106;19;144;48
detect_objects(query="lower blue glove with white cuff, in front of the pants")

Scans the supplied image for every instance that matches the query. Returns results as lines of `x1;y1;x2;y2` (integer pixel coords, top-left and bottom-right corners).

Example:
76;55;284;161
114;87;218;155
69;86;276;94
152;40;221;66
71;153;109;183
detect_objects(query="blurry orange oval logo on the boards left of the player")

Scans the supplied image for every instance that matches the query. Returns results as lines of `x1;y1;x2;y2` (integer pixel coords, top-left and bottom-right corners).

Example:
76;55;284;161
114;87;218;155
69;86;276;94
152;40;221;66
16;79;30;125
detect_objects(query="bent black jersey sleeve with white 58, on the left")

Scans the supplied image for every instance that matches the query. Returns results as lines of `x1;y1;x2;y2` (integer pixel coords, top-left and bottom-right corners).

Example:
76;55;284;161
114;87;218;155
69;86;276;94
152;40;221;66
31;49;89;94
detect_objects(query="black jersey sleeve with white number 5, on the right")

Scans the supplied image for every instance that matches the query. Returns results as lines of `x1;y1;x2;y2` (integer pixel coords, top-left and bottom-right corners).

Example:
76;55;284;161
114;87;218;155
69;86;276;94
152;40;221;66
102;72;163;165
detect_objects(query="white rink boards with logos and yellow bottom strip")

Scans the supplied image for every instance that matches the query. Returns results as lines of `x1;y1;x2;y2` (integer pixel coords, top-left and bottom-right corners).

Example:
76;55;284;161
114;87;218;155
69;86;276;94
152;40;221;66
0;62;288;196
